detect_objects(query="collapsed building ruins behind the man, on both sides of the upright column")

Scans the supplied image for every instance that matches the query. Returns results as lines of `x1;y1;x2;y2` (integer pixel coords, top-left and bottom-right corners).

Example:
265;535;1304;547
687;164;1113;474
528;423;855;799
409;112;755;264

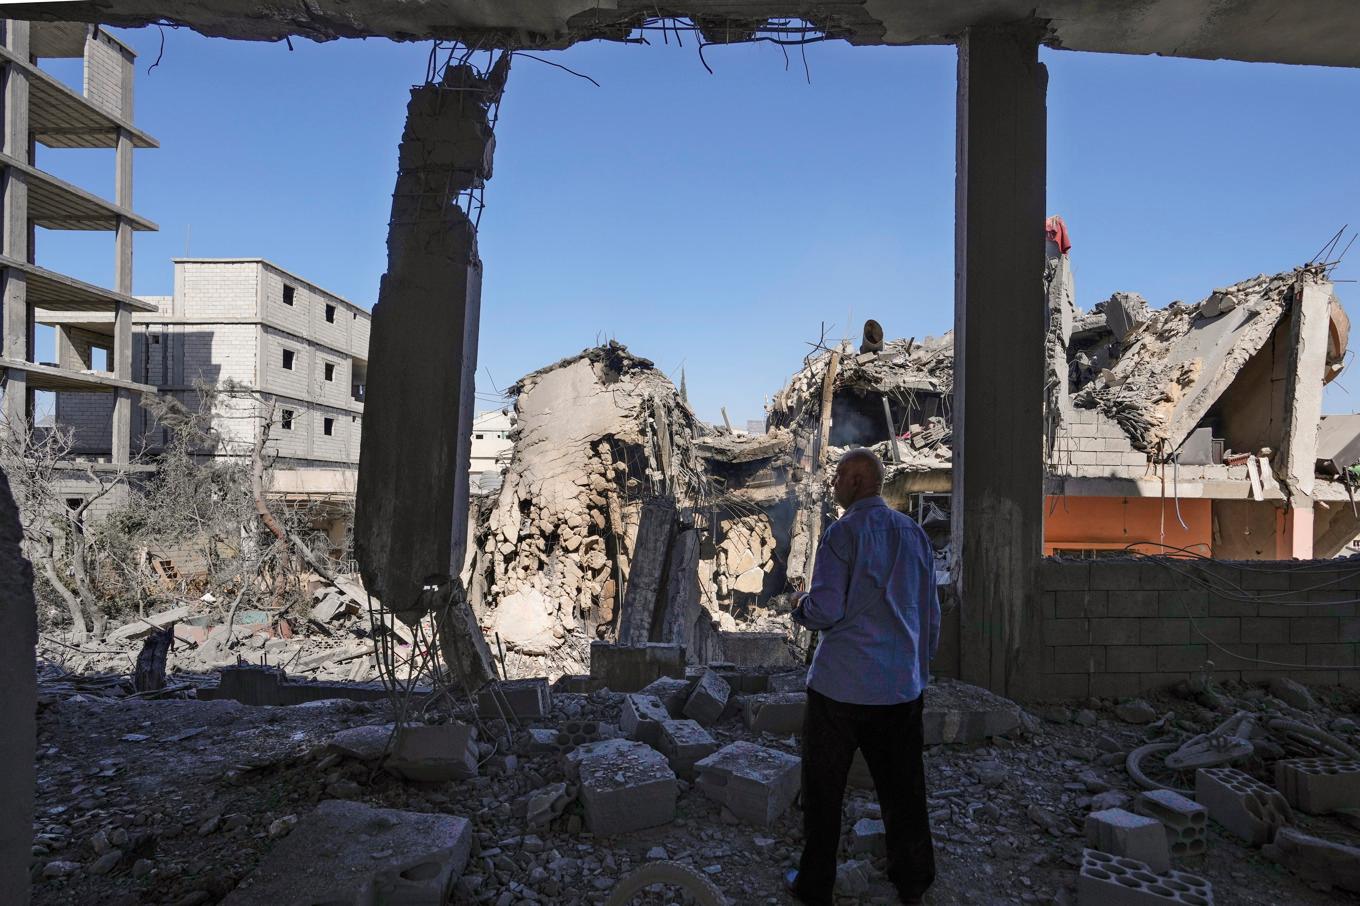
465;239;1360;676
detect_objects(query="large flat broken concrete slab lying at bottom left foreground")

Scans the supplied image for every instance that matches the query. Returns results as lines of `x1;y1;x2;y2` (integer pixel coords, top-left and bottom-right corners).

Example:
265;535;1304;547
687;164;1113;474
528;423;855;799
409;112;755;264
222;800;472;906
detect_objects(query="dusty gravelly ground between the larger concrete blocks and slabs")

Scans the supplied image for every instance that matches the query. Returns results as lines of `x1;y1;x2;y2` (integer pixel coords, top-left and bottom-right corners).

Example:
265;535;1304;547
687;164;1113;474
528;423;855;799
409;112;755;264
23;674;1360;906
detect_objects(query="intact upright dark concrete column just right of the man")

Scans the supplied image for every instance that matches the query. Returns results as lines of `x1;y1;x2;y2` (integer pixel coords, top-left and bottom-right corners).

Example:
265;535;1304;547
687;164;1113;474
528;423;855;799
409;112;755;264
953;23;1047;698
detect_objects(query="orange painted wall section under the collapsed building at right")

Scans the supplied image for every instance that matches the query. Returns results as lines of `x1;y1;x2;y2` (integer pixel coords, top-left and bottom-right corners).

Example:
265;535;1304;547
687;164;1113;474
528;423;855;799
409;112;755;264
1043;497;1213;555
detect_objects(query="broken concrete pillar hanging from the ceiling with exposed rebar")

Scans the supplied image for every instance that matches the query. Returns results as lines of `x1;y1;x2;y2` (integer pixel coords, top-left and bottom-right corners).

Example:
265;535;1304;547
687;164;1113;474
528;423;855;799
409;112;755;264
354;54;510;623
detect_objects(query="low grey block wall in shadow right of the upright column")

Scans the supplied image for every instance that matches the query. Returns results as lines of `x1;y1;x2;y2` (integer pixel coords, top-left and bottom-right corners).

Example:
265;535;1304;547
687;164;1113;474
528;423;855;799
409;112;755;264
1040;559;1360;698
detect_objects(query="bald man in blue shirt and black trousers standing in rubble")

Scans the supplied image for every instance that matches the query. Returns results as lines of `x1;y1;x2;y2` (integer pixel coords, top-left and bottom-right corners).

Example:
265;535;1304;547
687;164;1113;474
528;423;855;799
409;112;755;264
785;449;940;905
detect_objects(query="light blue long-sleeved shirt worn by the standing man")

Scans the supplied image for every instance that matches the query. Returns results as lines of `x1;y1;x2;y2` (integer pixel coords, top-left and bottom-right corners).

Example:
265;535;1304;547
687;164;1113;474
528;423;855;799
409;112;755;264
793;497;940;705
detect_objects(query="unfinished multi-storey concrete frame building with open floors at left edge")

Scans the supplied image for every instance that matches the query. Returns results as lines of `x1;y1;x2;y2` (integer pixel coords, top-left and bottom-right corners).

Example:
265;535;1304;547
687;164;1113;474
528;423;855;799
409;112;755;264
0;19;156;465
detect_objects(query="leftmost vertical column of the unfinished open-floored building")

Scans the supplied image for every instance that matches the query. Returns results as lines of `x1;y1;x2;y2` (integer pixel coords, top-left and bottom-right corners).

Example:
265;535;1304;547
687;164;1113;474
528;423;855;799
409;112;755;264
0;19;33;426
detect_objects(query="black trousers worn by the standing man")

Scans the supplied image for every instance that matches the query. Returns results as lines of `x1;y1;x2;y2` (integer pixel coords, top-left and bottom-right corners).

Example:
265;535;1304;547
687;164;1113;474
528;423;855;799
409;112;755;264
797;688;934;903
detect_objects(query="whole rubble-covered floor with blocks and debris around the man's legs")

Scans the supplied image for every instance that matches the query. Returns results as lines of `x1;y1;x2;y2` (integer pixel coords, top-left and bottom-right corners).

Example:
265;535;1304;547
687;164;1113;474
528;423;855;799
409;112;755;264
33;648;1360;906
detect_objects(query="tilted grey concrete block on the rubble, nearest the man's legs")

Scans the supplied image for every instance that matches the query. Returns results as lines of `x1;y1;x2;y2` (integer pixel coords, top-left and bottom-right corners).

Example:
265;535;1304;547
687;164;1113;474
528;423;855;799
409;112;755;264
695;741;802;826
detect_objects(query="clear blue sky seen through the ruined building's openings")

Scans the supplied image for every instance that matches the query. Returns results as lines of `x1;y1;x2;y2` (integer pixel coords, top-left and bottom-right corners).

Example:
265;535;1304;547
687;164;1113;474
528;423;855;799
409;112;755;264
37;29;1360;422
